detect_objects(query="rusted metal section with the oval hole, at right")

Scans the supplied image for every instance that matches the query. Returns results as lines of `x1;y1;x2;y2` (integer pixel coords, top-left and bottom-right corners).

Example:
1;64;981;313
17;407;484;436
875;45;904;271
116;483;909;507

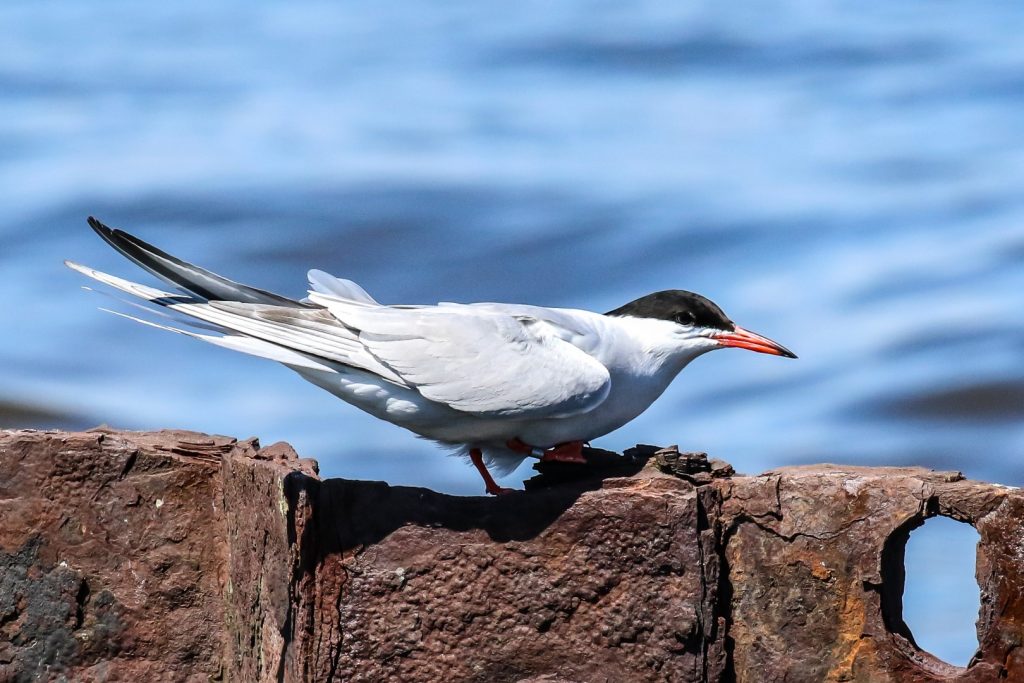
720;465;1024;682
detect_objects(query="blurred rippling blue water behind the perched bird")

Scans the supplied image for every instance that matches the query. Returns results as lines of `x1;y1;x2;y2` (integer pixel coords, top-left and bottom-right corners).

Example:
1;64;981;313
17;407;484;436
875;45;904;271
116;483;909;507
0;0;1024;660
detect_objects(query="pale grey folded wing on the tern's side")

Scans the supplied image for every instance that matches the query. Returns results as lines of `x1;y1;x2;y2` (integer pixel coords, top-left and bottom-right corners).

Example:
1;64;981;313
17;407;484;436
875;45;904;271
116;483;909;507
311;295;611;419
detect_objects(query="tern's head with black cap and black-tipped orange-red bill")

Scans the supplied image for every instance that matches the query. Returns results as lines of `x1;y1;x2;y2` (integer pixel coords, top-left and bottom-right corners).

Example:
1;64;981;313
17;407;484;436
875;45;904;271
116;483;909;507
605;290;797;358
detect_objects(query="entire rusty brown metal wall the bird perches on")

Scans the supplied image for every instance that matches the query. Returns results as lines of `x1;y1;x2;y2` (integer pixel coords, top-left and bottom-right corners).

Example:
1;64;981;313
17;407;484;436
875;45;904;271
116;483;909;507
0;430;1024;683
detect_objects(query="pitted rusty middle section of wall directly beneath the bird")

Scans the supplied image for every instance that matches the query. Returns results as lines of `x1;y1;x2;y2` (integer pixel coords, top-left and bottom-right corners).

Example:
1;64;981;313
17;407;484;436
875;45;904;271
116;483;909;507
292;477;724;681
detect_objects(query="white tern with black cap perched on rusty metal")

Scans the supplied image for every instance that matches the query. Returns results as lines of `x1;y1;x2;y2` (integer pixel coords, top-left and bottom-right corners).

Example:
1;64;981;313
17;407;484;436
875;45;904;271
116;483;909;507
65;218;797;494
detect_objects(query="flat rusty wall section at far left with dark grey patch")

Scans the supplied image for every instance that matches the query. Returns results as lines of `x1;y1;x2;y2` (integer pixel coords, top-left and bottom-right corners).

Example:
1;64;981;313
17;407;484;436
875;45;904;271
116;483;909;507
0;432;234;681
